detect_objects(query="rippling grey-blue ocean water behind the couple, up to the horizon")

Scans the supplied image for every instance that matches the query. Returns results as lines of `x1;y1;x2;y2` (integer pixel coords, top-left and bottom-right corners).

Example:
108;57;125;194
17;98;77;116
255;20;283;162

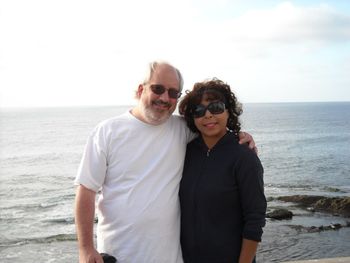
0;102;350;263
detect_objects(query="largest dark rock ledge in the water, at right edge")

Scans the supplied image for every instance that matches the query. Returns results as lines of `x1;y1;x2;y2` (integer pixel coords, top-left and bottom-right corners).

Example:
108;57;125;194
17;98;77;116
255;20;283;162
277;195;350;217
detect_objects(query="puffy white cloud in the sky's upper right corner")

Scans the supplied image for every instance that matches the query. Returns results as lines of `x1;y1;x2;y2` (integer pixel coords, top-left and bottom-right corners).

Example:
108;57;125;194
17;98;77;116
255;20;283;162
224;2;350;43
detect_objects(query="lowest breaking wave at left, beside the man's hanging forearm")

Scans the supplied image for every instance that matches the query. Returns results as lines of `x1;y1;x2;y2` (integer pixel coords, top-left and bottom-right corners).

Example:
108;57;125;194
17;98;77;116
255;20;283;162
0;234;77;247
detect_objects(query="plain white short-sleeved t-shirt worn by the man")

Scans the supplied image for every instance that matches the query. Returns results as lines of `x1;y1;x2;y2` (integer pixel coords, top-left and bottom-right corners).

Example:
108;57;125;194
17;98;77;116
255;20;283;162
75;112;193;263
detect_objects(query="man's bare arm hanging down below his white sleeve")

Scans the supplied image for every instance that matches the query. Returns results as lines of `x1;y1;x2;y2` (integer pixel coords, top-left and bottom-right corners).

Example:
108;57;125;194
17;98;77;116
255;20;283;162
75;185;103;263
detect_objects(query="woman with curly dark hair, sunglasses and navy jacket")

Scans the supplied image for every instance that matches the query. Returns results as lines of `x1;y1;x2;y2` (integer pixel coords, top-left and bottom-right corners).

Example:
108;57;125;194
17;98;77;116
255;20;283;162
179;79;266;263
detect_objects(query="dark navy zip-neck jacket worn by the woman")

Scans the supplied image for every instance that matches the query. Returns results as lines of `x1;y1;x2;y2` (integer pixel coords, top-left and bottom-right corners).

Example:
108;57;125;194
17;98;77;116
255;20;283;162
179;132;266;263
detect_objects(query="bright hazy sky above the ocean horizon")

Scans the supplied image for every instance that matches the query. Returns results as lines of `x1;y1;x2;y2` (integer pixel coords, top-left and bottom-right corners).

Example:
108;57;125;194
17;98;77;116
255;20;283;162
0;0;350;107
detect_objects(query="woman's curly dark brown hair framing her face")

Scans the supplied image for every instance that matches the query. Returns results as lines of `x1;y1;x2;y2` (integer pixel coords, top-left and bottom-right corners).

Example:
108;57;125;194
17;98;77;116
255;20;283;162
179;78;243;138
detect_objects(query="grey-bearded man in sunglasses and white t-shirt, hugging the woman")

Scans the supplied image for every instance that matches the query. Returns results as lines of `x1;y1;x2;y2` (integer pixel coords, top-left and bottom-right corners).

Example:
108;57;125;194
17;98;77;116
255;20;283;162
75;62;254;263
